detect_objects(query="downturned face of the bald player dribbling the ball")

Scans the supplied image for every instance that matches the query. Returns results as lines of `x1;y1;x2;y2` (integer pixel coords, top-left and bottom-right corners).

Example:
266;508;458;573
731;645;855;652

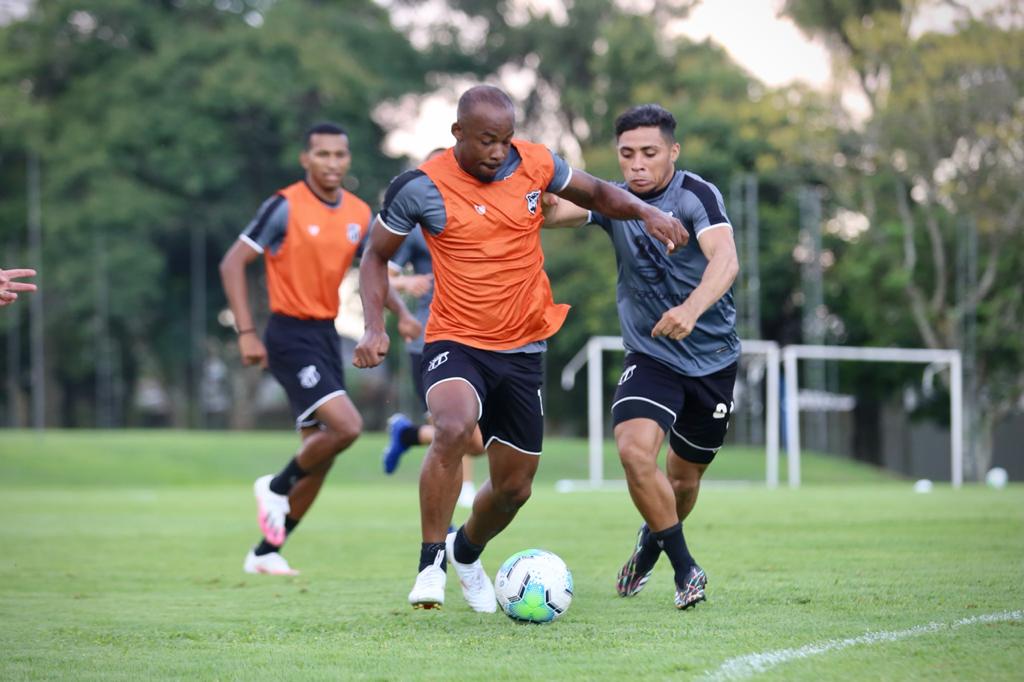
452;104;515;181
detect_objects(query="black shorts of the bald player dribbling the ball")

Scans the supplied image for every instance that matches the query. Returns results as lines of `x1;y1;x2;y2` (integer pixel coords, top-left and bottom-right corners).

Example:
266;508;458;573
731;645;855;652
423;341;544;455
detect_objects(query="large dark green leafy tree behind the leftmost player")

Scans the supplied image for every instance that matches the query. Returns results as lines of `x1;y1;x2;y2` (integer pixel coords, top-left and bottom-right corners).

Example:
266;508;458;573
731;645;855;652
0;0;425;425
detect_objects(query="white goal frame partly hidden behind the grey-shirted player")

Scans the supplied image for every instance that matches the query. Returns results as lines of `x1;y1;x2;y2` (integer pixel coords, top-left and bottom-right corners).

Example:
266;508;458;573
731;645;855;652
555;336;778;493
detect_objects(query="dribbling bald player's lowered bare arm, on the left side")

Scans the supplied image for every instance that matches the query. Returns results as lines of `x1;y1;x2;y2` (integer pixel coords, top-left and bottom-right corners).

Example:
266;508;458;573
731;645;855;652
352;219;408;368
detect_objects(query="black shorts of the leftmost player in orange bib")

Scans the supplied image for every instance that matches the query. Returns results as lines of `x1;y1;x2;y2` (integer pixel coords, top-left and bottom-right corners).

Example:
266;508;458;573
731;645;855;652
263;313;345;428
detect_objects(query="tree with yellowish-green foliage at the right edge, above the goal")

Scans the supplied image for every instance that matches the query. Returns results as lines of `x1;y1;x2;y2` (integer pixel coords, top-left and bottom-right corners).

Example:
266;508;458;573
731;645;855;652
786;1;1024;477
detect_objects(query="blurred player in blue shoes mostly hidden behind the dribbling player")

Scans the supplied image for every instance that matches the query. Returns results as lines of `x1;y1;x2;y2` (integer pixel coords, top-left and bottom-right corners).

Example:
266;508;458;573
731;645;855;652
382;147;483;509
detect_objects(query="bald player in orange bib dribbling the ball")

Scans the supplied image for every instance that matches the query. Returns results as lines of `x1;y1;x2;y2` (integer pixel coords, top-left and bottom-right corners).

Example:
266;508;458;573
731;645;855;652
353;86;687;611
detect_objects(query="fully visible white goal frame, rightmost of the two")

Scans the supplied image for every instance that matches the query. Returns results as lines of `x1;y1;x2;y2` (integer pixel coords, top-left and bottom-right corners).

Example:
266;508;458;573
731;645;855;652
782;345;964;487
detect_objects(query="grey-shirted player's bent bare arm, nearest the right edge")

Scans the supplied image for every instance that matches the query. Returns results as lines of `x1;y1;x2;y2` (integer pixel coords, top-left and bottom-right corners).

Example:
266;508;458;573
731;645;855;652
650;225;739;341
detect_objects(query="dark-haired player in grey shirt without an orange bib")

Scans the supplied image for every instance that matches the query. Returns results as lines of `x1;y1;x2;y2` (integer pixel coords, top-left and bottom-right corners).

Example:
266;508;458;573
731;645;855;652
545;104;739;609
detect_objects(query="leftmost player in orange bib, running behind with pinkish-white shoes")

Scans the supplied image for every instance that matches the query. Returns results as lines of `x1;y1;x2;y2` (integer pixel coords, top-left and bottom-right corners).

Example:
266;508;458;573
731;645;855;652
220;123;420;576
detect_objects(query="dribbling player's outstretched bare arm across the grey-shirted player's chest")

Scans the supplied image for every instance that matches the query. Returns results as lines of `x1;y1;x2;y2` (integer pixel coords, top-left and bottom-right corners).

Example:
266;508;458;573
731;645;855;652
555;169;690;253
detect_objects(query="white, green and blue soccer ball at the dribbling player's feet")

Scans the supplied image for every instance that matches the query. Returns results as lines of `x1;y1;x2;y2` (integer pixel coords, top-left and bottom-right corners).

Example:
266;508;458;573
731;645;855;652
495;549;572;623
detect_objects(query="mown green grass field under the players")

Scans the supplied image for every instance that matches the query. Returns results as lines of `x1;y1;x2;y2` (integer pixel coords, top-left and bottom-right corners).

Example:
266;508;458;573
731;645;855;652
0;431;1024;680
